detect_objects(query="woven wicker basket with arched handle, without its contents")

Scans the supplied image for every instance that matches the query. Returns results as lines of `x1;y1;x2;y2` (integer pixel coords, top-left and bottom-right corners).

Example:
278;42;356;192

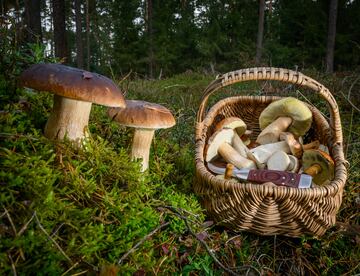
194;67;347;237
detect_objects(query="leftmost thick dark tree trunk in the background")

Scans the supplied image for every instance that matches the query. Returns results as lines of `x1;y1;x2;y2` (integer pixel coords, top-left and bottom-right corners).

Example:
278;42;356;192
25;0;42;43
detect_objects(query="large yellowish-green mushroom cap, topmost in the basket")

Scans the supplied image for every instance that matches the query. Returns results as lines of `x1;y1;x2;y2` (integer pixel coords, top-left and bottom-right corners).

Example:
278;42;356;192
259;97;312;136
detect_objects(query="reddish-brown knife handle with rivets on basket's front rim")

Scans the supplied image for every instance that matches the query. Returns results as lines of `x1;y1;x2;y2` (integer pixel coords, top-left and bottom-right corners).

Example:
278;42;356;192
248;170;301;188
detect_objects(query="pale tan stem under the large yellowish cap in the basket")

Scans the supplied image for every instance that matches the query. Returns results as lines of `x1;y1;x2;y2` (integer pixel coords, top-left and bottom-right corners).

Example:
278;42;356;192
256;117;292;145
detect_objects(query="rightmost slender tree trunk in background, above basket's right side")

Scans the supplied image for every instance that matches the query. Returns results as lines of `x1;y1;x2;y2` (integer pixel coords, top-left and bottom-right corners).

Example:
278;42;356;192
326;0;338;73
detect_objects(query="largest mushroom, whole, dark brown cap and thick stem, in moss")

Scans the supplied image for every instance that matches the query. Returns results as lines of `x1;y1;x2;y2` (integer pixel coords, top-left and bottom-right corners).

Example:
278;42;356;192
20;64;125;143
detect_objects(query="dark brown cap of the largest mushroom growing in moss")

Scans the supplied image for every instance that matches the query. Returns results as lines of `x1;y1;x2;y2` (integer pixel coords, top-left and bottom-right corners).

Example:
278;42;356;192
20;63;125;107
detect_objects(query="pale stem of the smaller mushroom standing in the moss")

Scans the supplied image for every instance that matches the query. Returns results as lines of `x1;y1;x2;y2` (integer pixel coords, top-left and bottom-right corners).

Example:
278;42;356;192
130;128;155;172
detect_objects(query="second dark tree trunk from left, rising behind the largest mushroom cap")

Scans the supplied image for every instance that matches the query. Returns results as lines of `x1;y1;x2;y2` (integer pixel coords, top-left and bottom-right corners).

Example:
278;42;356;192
53;0;69;63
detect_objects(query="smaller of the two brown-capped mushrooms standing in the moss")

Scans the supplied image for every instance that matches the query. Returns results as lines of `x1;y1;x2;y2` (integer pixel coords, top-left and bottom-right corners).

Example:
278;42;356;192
108;100;175;171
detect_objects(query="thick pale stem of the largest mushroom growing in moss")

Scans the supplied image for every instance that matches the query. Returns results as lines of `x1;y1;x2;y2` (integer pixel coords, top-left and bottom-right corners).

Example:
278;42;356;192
45;95;92;143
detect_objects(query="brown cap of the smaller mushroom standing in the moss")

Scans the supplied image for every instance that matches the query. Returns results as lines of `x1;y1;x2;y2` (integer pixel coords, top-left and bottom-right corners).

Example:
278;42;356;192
108;100;175;129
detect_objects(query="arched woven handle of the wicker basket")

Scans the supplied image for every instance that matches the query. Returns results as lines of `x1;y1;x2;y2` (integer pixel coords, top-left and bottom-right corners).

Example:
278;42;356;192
196;67;343;146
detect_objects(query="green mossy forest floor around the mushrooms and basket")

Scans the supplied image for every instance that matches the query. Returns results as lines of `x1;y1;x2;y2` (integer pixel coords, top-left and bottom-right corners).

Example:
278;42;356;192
0;71;360;275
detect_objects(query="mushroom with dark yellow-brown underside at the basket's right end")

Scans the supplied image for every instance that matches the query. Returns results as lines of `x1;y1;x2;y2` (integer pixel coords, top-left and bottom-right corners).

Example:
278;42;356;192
302;150;335;185
